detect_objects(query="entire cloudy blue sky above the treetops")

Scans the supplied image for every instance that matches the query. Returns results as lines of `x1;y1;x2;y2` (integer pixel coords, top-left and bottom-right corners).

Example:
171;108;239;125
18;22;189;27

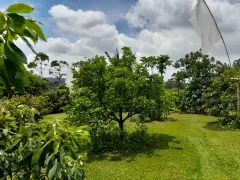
0;0;240;78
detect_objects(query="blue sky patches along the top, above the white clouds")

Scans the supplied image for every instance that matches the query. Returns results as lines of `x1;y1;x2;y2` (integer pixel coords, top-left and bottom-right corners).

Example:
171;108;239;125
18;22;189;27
0;0;139;37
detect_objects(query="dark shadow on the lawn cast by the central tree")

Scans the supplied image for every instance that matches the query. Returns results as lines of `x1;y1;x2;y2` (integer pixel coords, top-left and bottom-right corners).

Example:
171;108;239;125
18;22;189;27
88;134;182;163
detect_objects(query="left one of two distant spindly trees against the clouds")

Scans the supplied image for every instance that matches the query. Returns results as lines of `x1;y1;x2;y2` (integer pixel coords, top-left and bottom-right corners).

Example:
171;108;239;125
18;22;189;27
27;52;49;77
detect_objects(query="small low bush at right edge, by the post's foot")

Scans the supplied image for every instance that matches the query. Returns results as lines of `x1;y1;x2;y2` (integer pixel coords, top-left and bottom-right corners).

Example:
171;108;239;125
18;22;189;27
220;116;240;130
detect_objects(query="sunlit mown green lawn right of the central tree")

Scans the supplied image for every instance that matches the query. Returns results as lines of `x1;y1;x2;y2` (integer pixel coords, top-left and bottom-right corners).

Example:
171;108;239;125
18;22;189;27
43;114;240;180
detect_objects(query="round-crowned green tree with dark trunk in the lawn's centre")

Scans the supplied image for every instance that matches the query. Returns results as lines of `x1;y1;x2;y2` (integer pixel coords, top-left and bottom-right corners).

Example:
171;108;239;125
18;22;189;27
69;47;163;136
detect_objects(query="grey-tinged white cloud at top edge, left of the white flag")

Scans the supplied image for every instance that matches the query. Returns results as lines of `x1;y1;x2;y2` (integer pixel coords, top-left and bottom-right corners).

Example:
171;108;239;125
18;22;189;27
126;0;194;30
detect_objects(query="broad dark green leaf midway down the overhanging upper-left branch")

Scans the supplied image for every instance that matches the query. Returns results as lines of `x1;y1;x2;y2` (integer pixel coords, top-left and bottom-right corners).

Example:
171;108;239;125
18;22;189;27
4;42;27;65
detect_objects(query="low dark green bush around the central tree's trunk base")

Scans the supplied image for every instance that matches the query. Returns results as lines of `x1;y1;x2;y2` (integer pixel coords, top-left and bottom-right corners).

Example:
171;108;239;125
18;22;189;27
88;122;151;154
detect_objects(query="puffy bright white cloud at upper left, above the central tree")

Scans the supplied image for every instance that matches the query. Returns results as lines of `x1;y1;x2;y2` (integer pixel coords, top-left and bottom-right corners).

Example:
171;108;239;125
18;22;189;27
49;5;117;38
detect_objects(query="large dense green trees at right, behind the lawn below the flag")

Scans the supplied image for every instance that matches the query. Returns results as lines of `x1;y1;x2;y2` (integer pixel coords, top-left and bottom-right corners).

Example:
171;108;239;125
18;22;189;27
174;52;240;116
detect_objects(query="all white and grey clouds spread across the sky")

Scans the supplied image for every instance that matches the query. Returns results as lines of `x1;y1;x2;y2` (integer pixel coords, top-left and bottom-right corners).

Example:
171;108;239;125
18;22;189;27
17;0;240;78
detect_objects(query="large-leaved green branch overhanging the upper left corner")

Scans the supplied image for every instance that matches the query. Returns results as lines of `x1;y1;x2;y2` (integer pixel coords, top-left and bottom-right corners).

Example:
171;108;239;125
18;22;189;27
0;3;46;93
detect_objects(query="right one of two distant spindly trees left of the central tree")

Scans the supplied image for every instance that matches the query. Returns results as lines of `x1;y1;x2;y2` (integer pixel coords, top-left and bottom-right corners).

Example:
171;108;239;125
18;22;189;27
49;60;69;84
